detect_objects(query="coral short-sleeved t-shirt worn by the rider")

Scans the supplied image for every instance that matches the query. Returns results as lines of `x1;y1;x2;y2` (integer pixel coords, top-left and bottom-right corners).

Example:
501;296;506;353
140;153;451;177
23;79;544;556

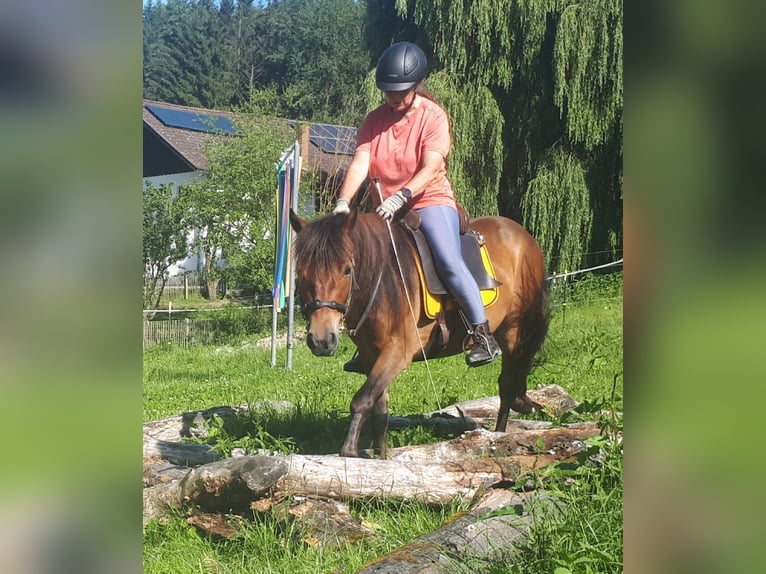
356;96;455;209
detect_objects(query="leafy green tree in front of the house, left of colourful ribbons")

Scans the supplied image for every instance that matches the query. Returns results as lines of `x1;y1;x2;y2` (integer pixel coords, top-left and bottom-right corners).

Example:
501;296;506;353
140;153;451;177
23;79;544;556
183;113;295;300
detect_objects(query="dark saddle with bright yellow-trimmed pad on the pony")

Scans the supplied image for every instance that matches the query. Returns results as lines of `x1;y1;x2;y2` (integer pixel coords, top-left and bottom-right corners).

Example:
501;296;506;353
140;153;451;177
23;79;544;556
400;204;501;360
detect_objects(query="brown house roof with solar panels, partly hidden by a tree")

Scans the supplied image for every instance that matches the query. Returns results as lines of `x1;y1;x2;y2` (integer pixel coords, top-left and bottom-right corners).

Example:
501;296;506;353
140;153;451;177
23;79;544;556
143;100;356;177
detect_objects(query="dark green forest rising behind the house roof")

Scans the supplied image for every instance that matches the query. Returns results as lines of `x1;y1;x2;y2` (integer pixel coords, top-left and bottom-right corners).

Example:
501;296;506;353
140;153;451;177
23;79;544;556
143;0;370;124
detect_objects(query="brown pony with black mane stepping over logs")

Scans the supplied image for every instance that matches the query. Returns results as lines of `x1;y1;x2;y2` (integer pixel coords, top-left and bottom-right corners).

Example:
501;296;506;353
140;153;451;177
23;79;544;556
290;210;548;458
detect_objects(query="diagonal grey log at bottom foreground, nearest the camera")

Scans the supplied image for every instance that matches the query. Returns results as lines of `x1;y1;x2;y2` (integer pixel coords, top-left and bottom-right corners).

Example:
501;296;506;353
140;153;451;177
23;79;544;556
357;489;557;574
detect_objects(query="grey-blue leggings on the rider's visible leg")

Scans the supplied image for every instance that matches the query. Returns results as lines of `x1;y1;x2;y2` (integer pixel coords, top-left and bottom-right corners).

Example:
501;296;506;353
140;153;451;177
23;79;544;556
417;205;487;325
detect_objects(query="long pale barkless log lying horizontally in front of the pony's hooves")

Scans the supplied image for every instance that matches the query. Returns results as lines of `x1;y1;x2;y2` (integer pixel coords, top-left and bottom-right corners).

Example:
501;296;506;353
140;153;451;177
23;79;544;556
144;454;520;521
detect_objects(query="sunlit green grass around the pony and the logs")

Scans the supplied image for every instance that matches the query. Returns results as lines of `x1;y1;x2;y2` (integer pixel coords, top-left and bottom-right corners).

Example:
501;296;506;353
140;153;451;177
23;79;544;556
143;273;623;574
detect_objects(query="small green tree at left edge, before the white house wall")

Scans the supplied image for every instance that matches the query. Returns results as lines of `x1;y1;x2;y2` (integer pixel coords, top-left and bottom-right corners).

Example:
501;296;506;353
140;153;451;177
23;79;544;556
143;183;189;309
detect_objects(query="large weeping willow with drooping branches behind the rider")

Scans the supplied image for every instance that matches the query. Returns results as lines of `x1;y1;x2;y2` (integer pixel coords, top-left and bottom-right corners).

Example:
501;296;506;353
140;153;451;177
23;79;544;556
378;0;623;270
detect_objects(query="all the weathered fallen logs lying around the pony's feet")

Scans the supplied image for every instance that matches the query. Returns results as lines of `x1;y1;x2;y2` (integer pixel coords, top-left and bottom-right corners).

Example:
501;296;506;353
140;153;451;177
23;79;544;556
143;385;600;573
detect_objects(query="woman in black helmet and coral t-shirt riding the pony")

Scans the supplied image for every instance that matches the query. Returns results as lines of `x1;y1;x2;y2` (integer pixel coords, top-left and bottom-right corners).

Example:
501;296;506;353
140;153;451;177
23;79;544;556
333;42;501;370
